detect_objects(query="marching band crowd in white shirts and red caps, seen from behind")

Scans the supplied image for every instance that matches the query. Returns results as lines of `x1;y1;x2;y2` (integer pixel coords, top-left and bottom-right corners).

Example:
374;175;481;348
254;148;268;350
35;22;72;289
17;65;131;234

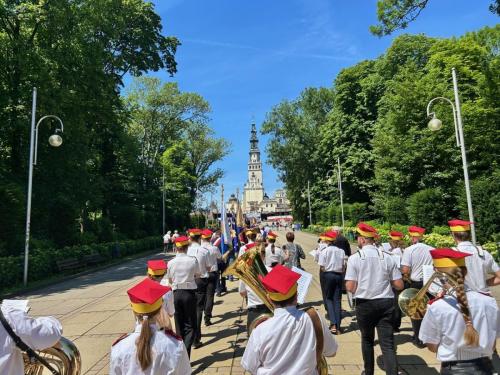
0;220;500;375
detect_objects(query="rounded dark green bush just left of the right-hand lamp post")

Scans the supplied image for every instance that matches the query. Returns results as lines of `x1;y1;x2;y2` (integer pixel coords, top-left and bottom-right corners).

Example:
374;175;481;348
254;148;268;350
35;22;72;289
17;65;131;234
408;189;447;230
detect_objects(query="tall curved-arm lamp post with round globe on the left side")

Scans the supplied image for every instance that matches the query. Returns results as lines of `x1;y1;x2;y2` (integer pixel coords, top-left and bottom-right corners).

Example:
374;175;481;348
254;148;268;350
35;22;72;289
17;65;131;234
23;87;64;286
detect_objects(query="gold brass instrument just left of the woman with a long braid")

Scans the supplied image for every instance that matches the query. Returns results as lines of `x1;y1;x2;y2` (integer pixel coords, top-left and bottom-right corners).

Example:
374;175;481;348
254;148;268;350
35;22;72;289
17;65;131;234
398;271;458;320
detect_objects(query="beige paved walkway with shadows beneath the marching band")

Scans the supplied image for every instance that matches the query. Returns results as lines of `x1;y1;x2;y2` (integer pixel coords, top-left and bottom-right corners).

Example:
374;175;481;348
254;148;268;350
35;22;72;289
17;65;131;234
17;232;498;375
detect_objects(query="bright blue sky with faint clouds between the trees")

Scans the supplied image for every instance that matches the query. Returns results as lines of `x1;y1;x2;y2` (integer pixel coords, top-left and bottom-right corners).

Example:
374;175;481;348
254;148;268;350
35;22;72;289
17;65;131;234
131;0;500;206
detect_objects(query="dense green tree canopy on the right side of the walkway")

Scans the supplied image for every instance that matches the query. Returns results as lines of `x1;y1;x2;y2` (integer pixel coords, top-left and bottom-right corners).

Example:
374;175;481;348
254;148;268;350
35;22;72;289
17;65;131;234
262;26;500;244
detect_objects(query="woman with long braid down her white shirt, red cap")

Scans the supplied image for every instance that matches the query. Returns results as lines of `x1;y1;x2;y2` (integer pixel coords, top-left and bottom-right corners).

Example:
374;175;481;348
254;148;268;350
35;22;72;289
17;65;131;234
419;248;500;375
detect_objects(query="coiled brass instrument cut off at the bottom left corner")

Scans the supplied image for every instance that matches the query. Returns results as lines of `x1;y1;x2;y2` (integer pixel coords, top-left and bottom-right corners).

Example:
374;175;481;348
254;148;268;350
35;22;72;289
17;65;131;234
23;337;82;375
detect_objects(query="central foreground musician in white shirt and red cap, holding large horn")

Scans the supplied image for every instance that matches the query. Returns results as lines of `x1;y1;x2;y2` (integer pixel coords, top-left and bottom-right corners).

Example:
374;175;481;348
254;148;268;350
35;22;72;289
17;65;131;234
241;265;338;375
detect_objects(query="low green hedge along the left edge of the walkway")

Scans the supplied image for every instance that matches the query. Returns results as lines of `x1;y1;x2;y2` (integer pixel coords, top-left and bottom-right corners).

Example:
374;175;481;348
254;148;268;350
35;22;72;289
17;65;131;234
0;236;162;289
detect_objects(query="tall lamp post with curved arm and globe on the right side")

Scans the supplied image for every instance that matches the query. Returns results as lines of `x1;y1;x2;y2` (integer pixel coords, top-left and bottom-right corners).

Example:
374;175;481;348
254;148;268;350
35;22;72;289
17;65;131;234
427;68;476;244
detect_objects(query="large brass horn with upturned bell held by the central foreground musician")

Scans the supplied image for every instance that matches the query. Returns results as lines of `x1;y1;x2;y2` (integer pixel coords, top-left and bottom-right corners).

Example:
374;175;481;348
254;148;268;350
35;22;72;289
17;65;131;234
226;248;328;375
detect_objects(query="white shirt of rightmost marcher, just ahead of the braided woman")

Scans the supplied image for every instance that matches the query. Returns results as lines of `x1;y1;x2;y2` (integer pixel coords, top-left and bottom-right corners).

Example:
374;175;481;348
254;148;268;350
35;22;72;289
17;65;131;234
456;241;499;292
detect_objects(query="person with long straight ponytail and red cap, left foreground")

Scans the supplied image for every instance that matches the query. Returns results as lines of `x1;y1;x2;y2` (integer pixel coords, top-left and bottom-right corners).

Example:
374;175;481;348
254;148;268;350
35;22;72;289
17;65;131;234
109;278;191;375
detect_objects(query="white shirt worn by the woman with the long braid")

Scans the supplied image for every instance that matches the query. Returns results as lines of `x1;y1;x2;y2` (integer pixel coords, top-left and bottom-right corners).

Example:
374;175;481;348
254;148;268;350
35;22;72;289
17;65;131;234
418;290;500;362
